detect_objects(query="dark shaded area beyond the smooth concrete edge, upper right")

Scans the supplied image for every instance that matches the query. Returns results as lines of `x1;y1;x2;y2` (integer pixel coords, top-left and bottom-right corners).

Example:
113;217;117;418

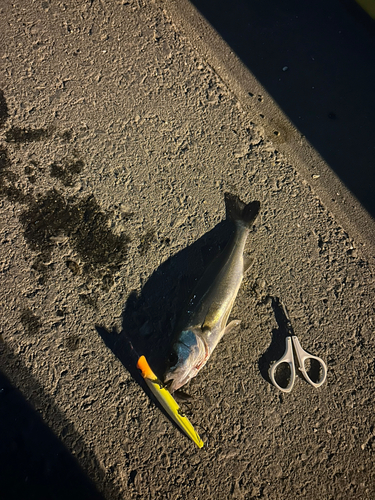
192;0;375;216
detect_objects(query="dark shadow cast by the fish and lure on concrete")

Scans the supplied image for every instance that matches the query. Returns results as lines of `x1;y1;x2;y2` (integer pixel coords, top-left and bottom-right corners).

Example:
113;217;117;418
96;219;234;392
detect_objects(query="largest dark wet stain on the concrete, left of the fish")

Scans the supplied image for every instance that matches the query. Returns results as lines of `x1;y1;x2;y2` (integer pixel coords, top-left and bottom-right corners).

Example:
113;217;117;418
19;190;129;289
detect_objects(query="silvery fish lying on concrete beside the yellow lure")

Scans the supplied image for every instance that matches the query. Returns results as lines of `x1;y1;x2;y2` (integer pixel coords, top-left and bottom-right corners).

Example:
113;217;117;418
164;193;260;394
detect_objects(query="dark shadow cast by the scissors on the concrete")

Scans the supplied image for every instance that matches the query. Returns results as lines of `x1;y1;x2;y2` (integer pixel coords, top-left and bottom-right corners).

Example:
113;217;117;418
258;297;291;385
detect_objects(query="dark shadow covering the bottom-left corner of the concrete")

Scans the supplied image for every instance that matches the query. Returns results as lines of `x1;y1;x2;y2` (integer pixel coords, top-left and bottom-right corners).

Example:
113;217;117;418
0;344;118;500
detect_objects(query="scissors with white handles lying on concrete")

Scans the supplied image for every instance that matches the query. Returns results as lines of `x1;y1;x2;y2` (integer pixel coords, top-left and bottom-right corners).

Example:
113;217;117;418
269;298;327;392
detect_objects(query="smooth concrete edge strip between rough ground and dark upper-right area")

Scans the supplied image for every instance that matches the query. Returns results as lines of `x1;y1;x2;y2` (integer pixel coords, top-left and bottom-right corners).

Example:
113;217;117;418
159;0;375;267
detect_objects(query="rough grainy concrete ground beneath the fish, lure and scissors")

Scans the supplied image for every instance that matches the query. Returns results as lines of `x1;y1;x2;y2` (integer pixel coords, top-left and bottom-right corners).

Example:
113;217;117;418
0;0;375;500
